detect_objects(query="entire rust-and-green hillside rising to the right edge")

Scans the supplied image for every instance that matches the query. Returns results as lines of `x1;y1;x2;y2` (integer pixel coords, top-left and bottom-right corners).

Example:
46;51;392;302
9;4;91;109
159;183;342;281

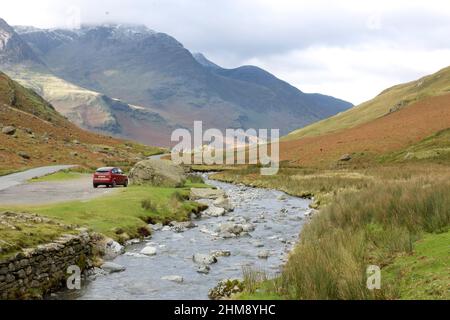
280;67;450;167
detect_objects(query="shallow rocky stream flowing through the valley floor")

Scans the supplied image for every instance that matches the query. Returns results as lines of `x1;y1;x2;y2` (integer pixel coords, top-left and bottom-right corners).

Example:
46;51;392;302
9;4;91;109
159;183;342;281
58;175;310;300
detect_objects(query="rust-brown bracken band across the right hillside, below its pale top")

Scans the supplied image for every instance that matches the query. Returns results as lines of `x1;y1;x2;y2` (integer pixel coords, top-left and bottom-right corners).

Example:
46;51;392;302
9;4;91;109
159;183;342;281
280;94;450;168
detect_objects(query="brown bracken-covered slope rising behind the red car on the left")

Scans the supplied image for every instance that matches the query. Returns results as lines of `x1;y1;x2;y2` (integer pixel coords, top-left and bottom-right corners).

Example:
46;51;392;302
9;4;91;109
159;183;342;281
0;72;159;173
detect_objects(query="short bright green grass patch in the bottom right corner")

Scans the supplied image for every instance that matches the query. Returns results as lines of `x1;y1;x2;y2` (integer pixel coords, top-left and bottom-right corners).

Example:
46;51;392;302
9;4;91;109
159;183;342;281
382;232;450;300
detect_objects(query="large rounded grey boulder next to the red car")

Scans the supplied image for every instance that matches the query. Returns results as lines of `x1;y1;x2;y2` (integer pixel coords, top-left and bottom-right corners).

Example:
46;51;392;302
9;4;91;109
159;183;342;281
129;159;186;187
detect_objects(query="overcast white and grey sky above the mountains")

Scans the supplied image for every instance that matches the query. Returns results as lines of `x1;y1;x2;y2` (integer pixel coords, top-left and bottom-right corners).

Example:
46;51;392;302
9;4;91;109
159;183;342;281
0;0;450;104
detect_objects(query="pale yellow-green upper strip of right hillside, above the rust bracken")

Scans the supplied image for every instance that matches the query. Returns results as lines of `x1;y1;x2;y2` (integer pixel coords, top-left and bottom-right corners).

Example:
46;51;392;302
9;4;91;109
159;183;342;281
284;67;450;140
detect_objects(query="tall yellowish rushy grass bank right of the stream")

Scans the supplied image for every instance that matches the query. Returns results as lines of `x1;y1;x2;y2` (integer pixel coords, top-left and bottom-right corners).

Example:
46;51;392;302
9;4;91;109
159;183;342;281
209;164;450;299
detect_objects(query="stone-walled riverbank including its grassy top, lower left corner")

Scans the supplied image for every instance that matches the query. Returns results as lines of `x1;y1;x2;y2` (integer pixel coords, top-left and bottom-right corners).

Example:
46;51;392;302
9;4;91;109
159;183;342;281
0;212;94;300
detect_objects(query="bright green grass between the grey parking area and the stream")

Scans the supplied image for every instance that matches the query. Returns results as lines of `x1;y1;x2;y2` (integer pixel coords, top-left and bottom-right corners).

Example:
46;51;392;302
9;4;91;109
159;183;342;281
0;183;208;241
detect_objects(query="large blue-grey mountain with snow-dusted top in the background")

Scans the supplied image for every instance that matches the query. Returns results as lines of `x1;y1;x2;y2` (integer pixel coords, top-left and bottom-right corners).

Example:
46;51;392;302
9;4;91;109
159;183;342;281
0;21;351;145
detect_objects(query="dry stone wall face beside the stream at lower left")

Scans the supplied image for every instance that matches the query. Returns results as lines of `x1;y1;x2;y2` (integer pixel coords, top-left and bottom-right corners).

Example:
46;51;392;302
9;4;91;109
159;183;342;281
0;229;92;299
